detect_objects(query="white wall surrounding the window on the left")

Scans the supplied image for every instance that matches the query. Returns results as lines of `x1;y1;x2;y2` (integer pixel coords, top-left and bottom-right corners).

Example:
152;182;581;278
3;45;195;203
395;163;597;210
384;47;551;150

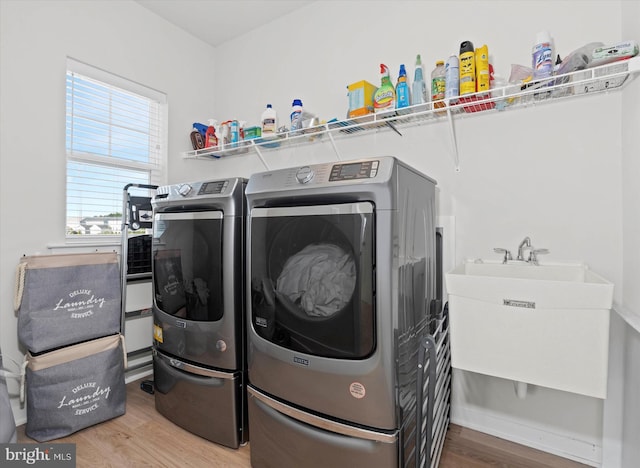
0;0;215;422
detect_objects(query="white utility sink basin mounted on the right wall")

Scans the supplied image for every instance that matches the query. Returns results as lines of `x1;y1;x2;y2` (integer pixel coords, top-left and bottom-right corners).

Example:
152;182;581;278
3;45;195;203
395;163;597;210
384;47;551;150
445;262;613;398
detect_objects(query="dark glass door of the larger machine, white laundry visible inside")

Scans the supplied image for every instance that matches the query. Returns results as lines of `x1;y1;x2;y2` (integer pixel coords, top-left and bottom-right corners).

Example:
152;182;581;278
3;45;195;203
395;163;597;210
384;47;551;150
250;202;375;359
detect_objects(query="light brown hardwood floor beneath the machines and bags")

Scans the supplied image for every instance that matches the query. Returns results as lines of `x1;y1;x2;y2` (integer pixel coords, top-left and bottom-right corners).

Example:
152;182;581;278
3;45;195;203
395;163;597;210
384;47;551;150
18;381;586;468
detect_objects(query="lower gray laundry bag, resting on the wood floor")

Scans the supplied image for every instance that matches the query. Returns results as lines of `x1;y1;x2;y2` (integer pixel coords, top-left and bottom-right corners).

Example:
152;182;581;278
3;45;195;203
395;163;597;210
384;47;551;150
25;334;126;442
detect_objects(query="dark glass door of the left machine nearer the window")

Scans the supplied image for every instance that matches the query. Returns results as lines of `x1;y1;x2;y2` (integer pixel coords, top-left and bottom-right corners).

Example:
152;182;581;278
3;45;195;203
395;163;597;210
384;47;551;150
152;211;223;322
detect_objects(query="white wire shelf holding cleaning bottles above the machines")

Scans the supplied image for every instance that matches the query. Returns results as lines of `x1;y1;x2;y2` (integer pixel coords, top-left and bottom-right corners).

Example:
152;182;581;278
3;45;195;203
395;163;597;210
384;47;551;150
183;56;640;171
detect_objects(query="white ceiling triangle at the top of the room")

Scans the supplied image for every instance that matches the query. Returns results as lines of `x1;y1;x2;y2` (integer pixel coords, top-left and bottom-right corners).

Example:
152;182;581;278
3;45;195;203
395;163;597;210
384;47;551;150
136;0;312;47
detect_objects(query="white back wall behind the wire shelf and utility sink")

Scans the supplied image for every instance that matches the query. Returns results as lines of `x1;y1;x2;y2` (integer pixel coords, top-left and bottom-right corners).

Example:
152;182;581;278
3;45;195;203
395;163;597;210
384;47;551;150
202;1;640;466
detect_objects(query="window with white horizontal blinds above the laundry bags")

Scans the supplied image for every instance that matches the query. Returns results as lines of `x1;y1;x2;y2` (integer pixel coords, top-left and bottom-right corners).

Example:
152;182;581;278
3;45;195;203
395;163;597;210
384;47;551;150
66;59;167;238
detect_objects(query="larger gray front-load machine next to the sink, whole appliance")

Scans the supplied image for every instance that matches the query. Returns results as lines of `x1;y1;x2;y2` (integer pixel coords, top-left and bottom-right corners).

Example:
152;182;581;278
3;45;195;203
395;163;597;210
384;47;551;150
246;157;439;468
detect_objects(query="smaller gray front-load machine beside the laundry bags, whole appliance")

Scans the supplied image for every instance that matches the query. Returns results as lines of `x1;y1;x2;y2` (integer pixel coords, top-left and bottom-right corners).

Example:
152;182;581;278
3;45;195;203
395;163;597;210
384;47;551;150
152;178;248;448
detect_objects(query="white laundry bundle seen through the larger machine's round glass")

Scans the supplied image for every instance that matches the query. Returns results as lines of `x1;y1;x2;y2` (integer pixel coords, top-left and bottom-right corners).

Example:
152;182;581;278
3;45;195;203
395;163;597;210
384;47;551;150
276;243;356;317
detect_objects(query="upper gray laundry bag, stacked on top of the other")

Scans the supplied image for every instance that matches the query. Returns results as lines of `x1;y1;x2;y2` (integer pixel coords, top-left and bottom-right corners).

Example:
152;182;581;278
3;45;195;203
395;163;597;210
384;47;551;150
14;252;122;353
